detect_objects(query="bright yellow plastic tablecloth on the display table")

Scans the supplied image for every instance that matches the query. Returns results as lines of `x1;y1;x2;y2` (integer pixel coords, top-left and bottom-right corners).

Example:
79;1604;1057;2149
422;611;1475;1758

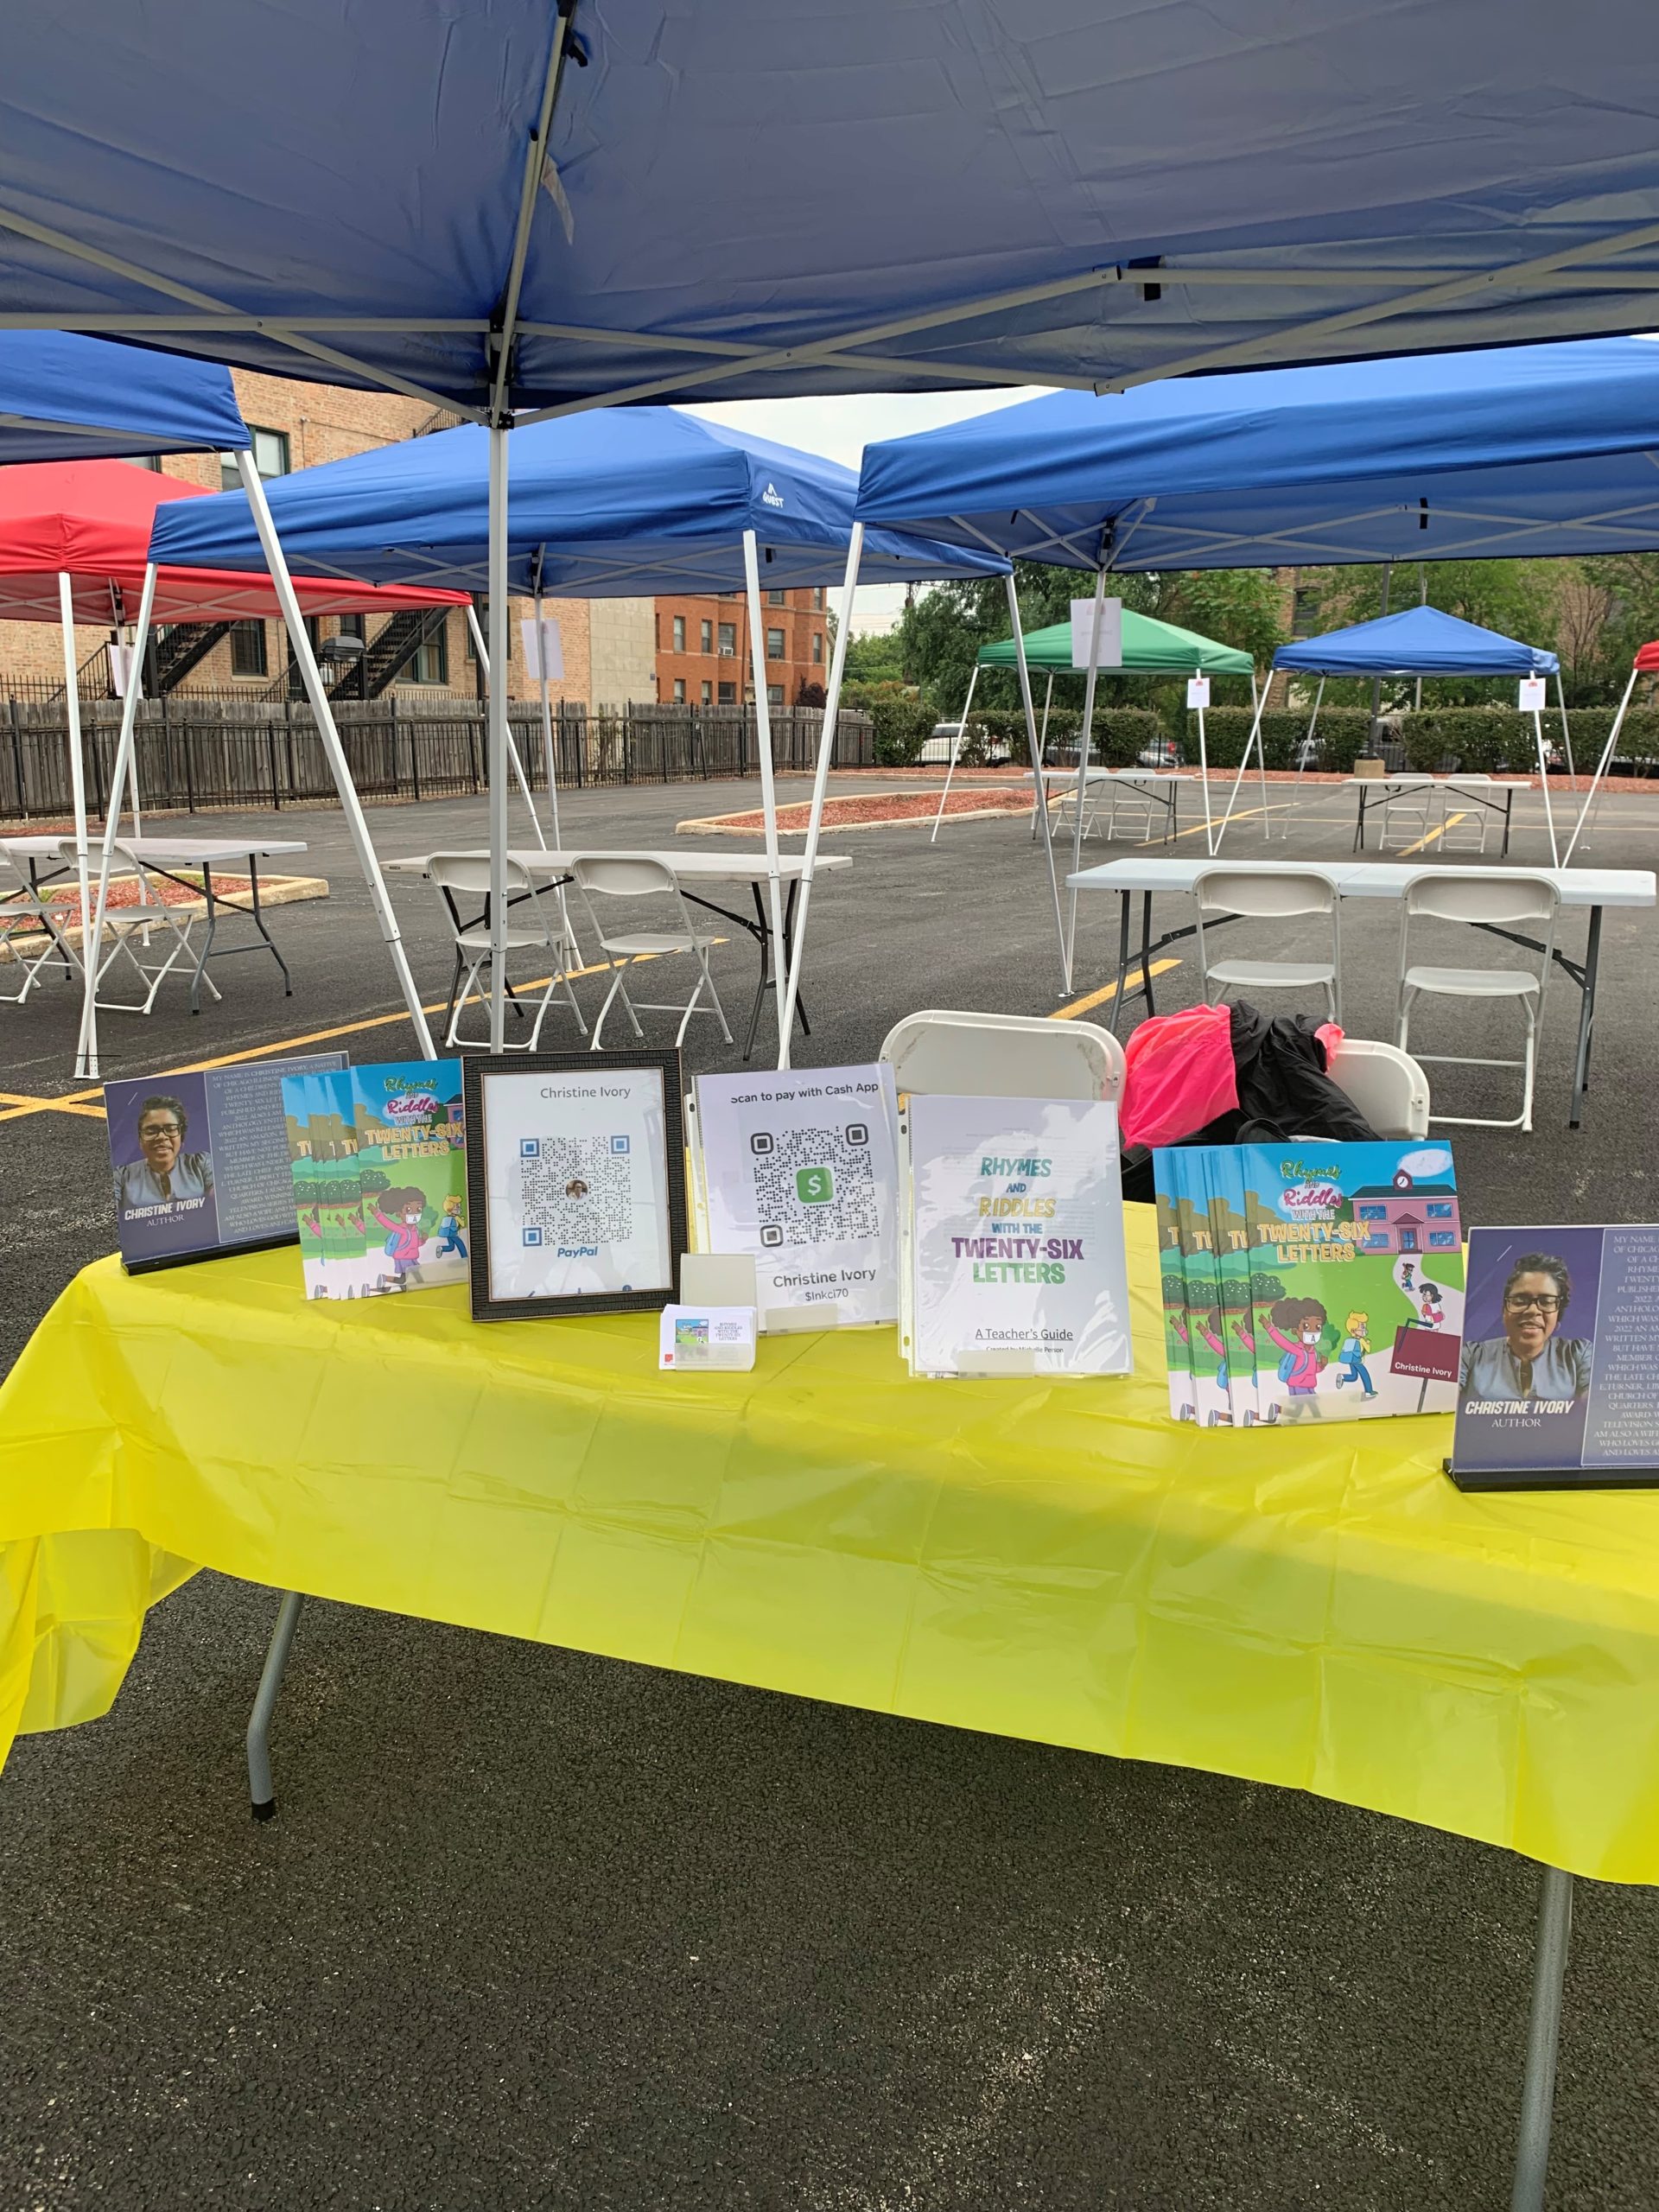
0;1208;1659;1883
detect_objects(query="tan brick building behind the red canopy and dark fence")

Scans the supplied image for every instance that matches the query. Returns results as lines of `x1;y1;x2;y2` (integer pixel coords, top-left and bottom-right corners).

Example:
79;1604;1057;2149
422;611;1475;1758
0;370;655;706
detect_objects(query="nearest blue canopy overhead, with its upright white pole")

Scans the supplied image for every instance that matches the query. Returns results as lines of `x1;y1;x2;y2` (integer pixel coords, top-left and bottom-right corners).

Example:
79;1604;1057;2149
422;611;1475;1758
0;0;1659;1061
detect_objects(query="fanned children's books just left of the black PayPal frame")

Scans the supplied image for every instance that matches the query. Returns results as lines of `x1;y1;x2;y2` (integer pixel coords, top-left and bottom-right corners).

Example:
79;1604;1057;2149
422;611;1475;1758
283;1059;467;1299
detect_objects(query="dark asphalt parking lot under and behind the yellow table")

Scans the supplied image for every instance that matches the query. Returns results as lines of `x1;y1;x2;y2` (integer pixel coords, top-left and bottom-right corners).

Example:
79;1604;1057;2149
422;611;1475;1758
0;777;1659;2212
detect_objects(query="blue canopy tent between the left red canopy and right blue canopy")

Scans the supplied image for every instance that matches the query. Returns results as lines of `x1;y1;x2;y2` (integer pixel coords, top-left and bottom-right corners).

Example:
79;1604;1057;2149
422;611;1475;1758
150;407;1008;1064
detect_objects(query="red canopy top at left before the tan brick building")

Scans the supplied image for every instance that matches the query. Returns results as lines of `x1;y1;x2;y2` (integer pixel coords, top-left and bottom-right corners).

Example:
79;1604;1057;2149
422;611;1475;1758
0;460;469;624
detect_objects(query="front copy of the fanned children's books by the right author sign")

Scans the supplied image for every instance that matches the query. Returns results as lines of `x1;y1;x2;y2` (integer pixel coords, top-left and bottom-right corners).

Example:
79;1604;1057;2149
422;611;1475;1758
1239;1144;1465;1422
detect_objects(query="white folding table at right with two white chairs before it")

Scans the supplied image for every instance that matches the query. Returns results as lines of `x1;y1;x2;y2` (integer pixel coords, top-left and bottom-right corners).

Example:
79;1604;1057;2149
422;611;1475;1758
1066;854;1659;1128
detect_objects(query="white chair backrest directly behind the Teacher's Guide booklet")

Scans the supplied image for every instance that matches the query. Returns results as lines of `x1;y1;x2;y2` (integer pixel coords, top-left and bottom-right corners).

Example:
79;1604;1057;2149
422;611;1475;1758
880;1008;1123;1099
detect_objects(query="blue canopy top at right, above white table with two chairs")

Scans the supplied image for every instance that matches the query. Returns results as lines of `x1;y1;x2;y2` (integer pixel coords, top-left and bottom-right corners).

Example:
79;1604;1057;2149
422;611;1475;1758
858;339;1659;977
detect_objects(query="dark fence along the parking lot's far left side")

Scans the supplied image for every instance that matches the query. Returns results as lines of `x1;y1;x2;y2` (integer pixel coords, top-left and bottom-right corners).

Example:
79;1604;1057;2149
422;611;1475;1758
0;696;874;821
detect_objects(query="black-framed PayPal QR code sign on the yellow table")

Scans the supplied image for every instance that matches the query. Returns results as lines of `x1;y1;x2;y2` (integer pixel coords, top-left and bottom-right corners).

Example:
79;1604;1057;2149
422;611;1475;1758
462;1051;686;1320
